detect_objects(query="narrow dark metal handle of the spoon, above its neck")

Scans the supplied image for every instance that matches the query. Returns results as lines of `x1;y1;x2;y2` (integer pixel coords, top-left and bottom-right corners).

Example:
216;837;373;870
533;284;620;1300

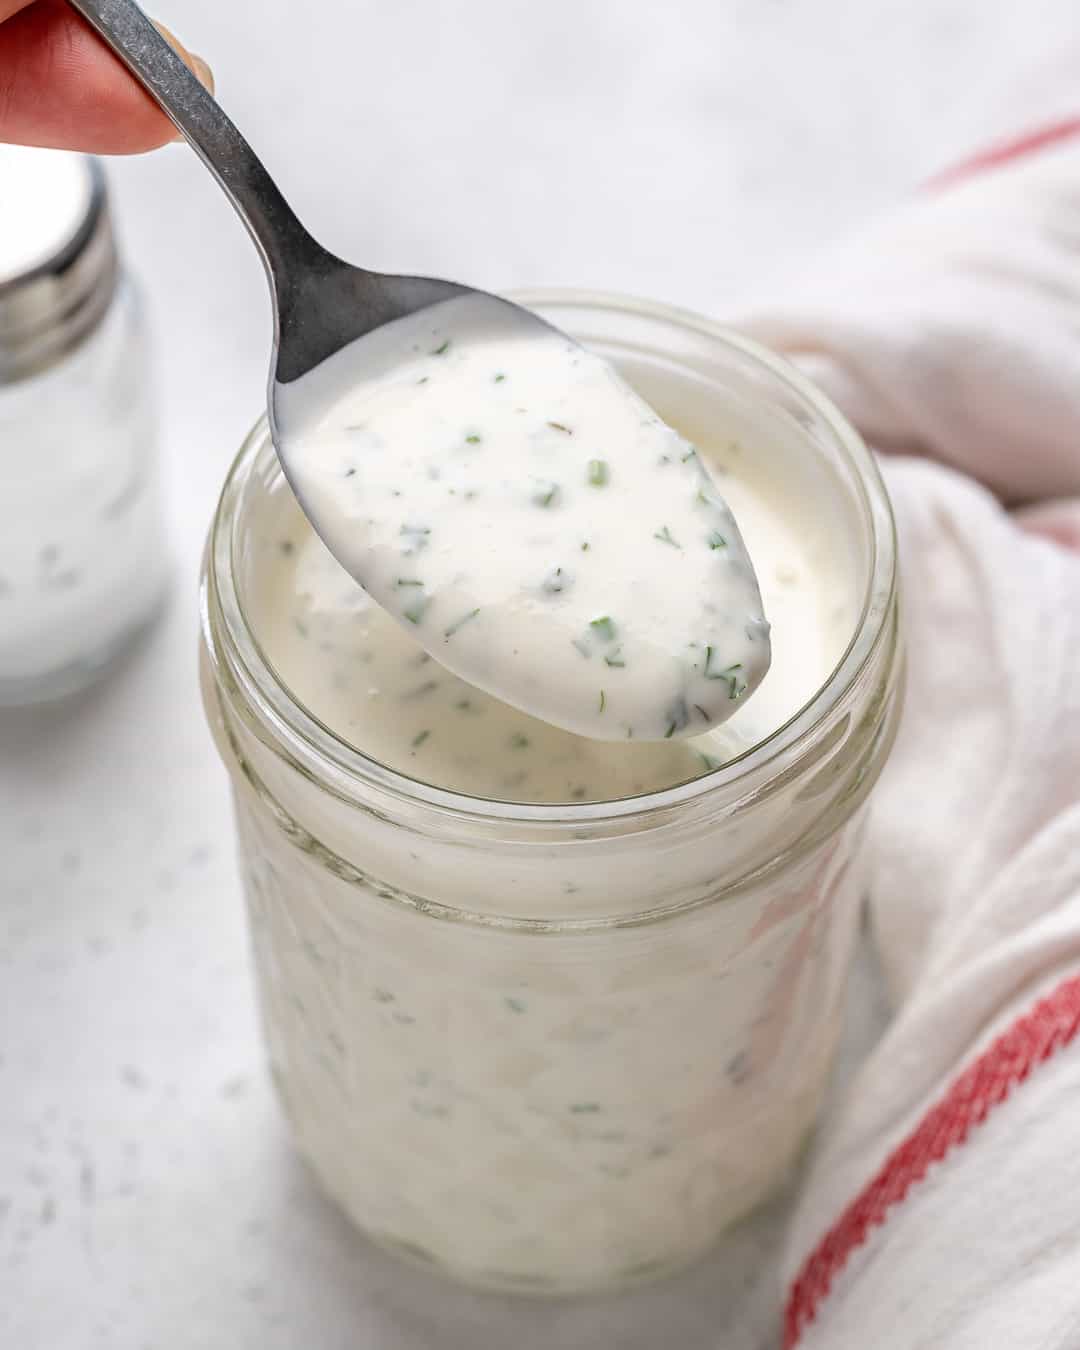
69;0;321;292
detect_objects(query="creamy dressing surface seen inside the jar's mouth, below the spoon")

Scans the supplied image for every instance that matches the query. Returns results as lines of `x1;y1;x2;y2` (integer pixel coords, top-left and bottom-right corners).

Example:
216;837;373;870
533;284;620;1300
252;437;848;802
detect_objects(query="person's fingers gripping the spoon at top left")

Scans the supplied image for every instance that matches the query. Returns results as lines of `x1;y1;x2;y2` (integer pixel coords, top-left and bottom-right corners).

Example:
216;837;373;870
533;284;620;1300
0;0;212;154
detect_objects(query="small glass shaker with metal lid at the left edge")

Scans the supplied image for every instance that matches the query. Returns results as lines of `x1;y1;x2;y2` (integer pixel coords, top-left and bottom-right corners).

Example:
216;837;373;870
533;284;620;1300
0;146;166;705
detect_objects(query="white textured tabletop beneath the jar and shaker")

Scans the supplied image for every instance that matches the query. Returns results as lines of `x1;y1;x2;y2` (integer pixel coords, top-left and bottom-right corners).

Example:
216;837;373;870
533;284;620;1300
0;0;1080;1350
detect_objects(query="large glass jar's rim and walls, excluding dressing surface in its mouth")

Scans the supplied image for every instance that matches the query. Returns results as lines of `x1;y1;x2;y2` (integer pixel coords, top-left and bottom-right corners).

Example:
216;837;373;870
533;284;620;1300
203;293;902;1292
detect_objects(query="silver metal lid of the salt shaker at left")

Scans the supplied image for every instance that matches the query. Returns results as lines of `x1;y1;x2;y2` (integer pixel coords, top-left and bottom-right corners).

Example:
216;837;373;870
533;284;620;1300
0;146;117;385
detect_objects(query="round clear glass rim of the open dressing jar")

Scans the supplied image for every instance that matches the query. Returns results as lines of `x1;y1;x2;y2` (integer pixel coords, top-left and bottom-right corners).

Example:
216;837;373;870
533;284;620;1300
201;289;896;826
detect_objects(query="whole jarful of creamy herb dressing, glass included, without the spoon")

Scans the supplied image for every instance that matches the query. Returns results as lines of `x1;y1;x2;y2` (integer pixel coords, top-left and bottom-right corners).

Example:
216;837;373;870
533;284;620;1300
203;298;900;1292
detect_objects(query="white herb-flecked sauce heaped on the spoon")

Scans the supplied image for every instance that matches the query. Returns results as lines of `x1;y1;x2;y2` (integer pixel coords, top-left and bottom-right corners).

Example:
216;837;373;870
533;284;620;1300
277;296;771;741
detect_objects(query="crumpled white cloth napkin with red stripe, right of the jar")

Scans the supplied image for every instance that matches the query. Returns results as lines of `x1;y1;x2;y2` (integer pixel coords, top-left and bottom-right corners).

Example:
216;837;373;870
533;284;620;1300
736;128;1080;1350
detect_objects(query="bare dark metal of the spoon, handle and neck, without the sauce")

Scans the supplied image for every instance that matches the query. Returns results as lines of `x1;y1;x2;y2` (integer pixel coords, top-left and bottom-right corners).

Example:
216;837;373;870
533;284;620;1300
62;0;540;459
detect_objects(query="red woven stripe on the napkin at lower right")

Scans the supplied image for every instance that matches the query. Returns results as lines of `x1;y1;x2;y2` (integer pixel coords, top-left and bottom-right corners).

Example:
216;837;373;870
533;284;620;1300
784;975;1080;1350
